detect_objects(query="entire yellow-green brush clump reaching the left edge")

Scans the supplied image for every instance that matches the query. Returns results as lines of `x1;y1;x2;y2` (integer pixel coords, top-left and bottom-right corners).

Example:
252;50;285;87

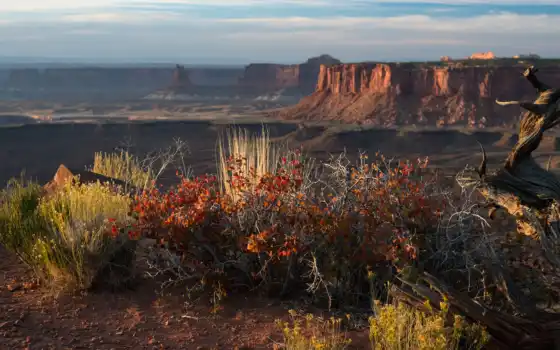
0;176;137;289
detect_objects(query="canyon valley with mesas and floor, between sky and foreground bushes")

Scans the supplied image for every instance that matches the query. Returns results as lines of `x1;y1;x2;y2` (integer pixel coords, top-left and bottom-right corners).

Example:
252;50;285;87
0;55;560;182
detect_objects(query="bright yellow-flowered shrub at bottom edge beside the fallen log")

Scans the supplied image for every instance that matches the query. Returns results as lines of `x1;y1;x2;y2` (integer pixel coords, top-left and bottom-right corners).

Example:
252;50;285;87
369;301;489;350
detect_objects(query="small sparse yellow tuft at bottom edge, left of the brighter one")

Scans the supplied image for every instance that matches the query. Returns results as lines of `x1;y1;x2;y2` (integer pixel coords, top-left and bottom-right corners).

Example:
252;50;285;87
277;310;351;350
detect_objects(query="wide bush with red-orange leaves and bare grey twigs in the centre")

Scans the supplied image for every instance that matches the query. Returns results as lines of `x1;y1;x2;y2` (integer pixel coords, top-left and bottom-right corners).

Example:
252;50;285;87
133;151;445;306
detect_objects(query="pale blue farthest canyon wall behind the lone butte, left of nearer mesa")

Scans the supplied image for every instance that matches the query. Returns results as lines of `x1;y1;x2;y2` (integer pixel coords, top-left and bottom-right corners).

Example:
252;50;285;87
0;66;244;100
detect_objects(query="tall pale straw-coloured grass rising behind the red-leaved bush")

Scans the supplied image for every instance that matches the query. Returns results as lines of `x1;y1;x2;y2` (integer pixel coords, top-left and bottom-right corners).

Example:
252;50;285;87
218;126;282;201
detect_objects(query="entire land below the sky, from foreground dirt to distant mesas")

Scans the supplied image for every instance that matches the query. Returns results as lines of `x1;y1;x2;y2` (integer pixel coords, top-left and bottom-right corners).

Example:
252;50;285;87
0;13;560;350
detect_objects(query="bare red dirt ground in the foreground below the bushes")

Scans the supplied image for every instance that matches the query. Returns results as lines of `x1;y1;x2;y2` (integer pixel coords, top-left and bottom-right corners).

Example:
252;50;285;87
0;247;369;350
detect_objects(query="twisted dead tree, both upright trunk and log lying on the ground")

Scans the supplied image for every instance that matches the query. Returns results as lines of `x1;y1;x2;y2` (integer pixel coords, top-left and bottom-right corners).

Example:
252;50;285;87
392;67;560;349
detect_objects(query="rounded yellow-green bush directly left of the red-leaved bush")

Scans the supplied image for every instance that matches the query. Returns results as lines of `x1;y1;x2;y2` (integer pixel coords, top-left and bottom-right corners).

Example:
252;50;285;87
34;182;138;289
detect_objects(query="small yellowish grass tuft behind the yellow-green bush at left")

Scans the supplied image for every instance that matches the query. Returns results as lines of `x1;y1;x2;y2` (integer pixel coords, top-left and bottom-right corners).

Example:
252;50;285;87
92;151;153;189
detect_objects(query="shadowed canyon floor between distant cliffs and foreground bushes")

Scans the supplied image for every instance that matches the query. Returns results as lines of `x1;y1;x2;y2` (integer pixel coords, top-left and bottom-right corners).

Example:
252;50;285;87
0;101;560;183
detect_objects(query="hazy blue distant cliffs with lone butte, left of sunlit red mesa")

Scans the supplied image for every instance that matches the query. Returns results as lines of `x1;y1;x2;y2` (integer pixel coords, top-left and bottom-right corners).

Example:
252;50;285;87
0;55;340;100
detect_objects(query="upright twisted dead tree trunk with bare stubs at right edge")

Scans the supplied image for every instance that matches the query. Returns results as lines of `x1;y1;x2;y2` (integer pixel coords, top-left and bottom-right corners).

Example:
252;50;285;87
470;67;560;267
